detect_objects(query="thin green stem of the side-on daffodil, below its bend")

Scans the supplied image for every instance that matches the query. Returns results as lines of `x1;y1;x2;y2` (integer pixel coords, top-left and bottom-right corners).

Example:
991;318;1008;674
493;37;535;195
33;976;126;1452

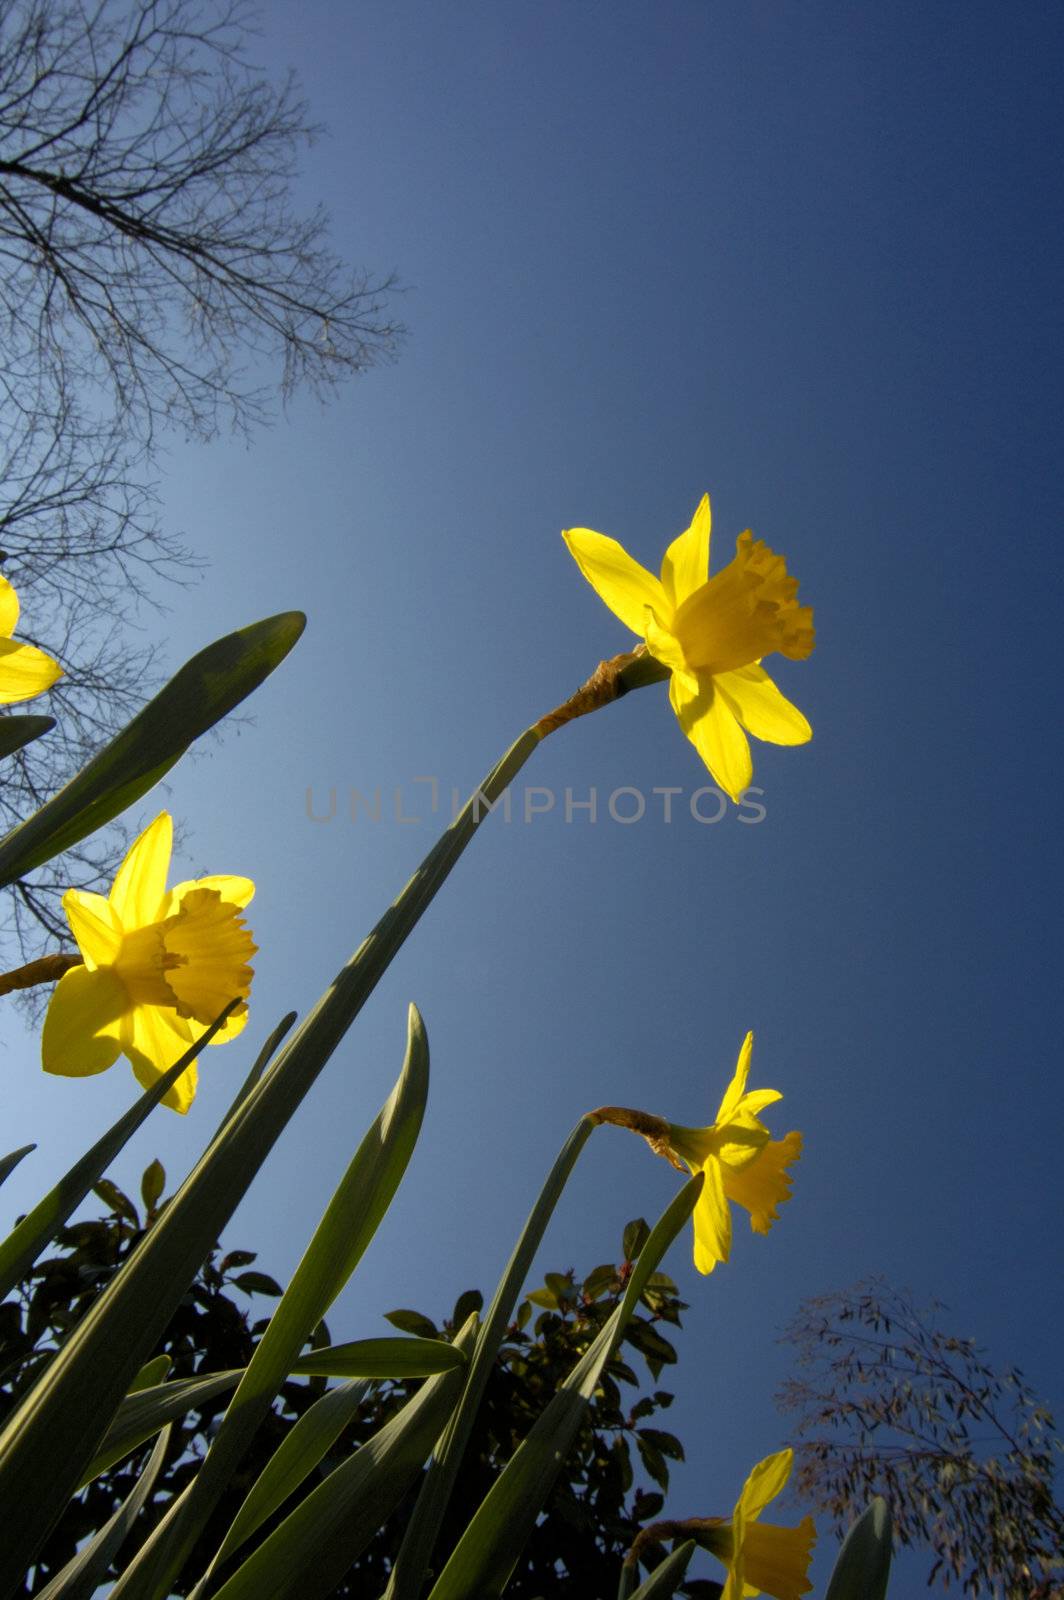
382;1117;595;1600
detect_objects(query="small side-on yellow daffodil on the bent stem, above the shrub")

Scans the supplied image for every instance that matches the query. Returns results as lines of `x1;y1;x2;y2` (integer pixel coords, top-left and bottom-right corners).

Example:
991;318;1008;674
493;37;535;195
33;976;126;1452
661;1034;802;1272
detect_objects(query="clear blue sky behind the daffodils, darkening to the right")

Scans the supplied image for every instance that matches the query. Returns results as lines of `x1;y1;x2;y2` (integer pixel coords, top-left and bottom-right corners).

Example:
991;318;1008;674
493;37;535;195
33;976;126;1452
5;0;1064;1587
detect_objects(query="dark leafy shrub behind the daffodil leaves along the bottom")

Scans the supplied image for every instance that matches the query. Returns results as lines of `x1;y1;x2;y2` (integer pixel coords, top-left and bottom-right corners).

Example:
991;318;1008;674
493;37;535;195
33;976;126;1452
0;1162;718;1600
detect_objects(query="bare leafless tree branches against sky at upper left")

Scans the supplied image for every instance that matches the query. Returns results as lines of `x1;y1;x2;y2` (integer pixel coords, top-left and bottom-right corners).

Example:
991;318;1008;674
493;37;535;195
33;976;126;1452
0;0;402;958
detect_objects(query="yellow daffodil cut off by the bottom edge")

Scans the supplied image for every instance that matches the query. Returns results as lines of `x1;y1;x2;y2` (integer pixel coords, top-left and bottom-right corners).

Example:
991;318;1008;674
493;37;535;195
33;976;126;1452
699;1450;816;1600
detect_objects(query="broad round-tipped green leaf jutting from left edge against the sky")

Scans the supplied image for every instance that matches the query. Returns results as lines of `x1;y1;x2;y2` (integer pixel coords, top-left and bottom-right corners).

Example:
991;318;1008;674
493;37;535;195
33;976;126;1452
0;611;306;888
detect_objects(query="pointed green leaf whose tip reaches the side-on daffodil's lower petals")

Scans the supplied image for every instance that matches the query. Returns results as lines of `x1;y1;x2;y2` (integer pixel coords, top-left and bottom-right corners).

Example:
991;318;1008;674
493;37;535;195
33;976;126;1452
429;1173;702;1600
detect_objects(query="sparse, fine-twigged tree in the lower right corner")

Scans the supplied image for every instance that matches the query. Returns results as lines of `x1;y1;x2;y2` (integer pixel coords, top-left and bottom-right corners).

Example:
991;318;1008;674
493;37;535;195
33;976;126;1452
776;1278;1064;1600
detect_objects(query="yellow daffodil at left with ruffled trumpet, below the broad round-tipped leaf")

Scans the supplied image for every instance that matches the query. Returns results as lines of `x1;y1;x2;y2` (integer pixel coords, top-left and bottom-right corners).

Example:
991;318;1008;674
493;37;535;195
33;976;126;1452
42;811;258;1112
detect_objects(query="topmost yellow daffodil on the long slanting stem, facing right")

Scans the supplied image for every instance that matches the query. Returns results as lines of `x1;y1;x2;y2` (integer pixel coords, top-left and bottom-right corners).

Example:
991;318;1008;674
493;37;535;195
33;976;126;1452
563;494;814;800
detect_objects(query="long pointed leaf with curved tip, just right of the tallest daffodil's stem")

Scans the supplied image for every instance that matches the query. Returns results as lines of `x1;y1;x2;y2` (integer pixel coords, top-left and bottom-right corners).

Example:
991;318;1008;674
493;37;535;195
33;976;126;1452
104;1006;428;1600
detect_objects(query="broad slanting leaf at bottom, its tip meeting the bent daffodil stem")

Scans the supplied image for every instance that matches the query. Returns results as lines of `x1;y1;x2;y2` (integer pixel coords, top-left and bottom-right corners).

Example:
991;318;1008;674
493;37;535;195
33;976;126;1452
204;1312;477;1600
